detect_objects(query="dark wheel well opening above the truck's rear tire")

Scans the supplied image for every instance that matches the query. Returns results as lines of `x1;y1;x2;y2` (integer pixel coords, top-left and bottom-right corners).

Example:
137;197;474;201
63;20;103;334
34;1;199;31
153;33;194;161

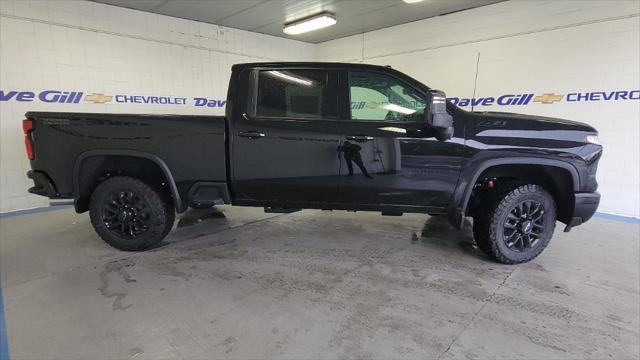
75;155;175;212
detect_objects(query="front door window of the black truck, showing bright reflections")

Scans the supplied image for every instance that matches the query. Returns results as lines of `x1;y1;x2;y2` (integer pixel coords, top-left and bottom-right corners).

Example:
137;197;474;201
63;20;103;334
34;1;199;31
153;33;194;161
349;71;425;121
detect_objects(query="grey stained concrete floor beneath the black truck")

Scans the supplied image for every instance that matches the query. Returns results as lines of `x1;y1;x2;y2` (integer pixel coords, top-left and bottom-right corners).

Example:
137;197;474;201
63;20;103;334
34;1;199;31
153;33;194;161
0;206;640;359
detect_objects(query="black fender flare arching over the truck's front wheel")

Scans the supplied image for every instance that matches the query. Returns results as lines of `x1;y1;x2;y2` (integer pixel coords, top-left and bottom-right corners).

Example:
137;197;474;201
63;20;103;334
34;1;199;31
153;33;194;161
449;157;580;228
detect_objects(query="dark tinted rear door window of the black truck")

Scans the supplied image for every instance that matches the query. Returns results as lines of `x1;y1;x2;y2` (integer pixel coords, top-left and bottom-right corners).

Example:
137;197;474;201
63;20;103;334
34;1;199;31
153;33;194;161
256;70;336;118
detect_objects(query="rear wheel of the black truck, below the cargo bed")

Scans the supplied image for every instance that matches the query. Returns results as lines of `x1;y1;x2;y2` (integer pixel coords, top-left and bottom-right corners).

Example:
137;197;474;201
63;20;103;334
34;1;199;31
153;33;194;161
89;176;175;251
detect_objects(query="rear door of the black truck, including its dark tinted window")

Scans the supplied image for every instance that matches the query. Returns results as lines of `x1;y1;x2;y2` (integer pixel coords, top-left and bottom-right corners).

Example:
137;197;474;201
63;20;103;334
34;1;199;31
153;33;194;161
230;68;339;204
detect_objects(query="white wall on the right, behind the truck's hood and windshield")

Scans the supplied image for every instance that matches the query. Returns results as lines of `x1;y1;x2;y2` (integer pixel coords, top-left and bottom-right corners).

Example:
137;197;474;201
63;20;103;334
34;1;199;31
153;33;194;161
317;1;640;217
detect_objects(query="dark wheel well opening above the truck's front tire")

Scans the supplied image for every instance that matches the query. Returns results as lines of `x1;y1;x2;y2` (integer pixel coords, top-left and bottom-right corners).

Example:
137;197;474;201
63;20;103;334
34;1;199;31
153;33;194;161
468;164;574;223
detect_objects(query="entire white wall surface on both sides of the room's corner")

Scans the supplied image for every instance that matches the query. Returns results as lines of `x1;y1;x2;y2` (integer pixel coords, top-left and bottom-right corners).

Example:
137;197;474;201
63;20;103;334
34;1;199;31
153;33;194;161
0;0;640;217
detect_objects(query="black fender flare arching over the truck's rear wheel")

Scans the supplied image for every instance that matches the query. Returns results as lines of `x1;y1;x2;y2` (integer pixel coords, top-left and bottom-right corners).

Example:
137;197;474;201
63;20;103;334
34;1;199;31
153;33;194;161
72;149;186;213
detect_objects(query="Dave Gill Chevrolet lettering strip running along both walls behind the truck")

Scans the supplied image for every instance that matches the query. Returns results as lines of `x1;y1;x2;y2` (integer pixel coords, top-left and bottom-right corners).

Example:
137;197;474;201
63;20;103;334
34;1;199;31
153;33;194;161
0;90;640;108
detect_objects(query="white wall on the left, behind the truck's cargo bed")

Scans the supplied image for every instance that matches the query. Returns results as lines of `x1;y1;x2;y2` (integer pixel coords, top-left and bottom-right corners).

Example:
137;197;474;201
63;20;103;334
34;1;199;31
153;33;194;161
0;0;315;212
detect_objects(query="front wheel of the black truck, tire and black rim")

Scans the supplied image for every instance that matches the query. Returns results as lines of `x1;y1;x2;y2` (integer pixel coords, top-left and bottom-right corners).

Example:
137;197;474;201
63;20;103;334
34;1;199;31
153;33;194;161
473;183;556;264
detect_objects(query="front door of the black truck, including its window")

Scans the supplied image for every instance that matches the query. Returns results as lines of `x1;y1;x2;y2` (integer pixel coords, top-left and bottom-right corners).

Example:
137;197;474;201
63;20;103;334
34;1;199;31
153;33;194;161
339;71;464;208
